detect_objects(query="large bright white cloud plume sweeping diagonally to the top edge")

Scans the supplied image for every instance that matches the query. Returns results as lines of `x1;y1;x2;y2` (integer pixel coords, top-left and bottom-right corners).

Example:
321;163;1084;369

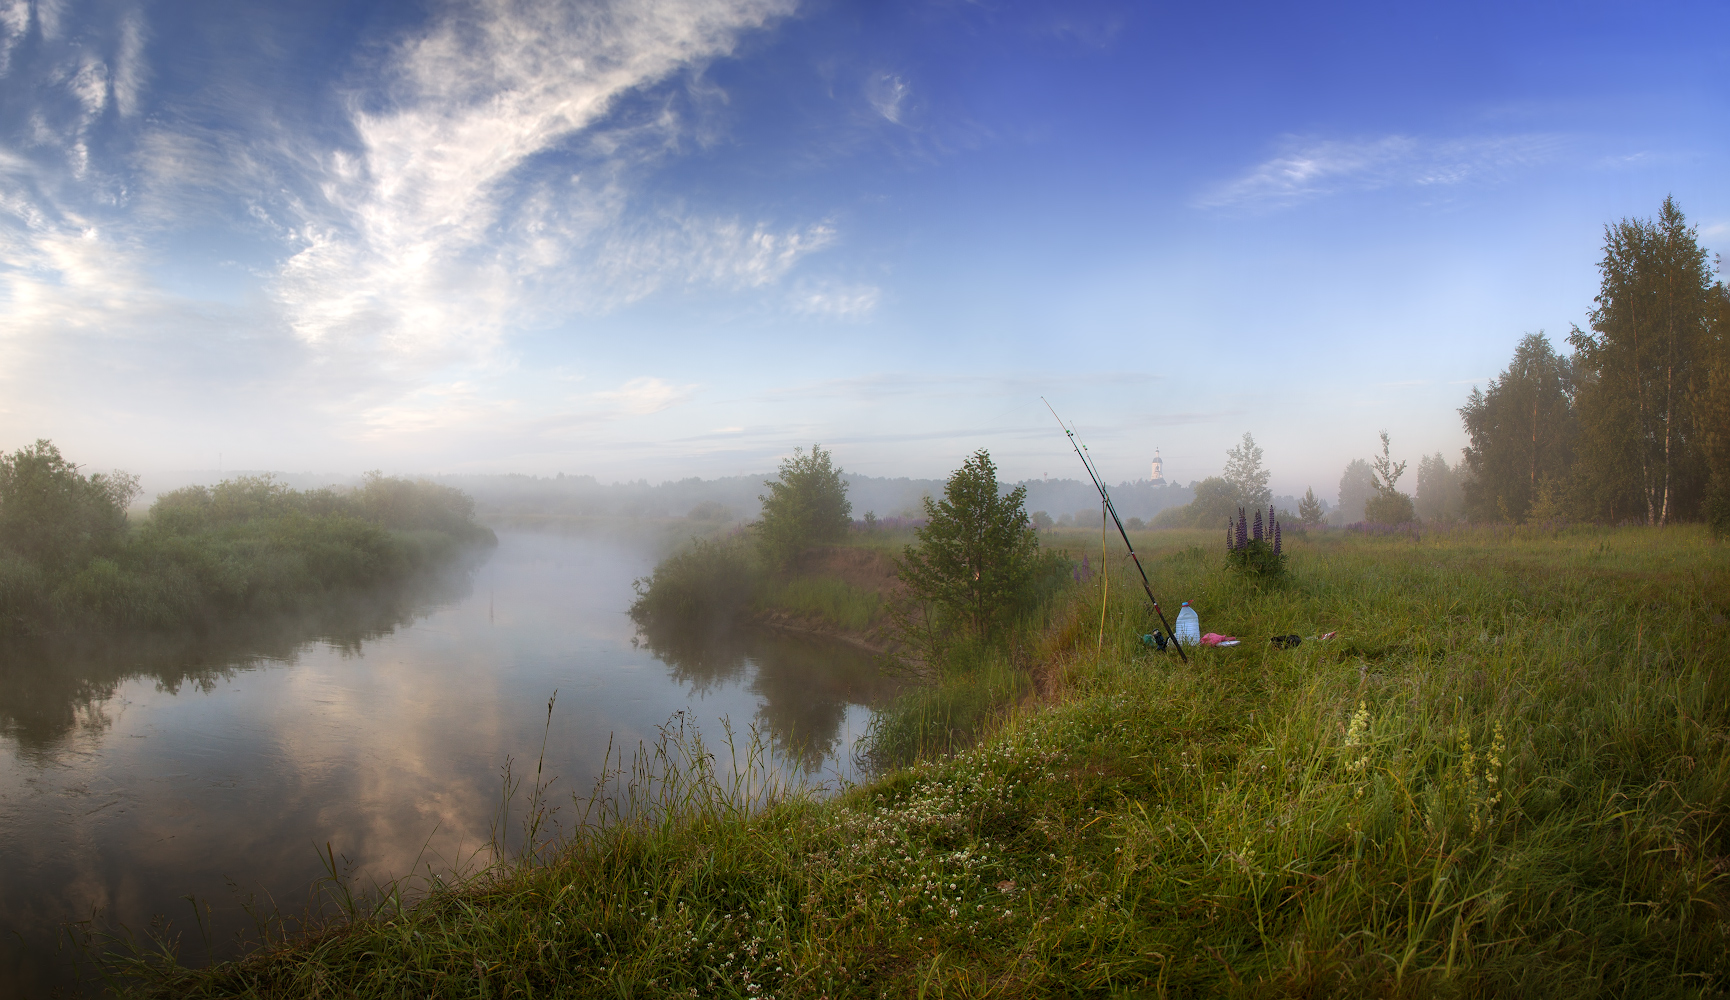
272;0;809;365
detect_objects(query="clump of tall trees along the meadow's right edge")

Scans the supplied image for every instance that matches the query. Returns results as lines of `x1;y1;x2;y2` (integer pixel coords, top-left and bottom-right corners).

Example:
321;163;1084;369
1453;192;1730;531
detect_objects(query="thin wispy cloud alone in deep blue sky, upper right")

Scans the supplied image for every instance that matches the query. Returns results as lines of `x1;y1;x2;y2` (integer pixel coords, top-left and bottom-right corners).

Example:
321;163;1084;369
1195;133;1564;208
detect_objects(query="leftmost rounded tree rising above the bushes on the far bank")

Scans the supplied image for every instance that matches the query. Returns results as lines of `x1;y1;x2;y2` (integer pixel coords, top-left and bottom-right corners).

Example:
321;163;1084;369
0;438;138;571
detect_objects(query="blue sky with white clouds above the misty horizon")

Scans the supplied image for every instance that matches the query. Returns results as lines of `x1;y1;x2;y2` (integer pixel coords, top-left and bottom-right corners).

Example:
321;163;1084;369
0;0;1730;498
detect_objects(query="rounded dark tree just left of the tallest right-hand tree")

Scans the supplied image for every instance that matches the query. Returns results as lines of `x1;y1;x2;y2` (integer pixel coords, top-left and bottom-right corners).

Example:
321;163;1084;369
1460;332;1576;521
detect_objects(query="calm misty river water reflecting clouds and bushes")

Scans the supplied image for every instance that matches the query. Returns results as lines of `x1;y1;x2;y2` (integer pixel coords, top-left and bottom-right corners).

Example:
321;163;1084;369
0;533;893;997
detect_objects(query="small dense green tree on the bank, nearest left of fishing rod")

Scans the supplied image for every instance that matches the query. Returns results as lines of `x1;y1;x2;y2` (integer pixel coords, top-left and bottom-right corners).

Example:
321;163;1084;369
896;448;1040;638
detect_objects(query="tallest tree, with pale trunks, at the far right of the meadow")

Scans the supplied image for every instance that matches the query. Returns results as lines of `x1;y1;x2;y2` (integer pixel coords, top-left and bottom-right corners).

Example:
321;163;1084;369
1569;197;1713;526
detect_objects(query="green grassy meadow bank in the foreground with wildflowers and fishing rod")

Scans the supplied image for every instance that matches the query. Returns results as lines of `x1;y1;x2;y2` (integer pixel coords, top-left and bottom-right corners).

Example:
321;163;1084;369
111;528;1730;997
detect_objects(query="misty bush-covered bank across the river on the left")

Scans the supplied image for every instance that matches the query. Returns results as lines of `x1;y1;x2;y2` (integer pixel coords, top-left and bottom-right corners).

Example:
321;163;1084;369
0;476;493;637
